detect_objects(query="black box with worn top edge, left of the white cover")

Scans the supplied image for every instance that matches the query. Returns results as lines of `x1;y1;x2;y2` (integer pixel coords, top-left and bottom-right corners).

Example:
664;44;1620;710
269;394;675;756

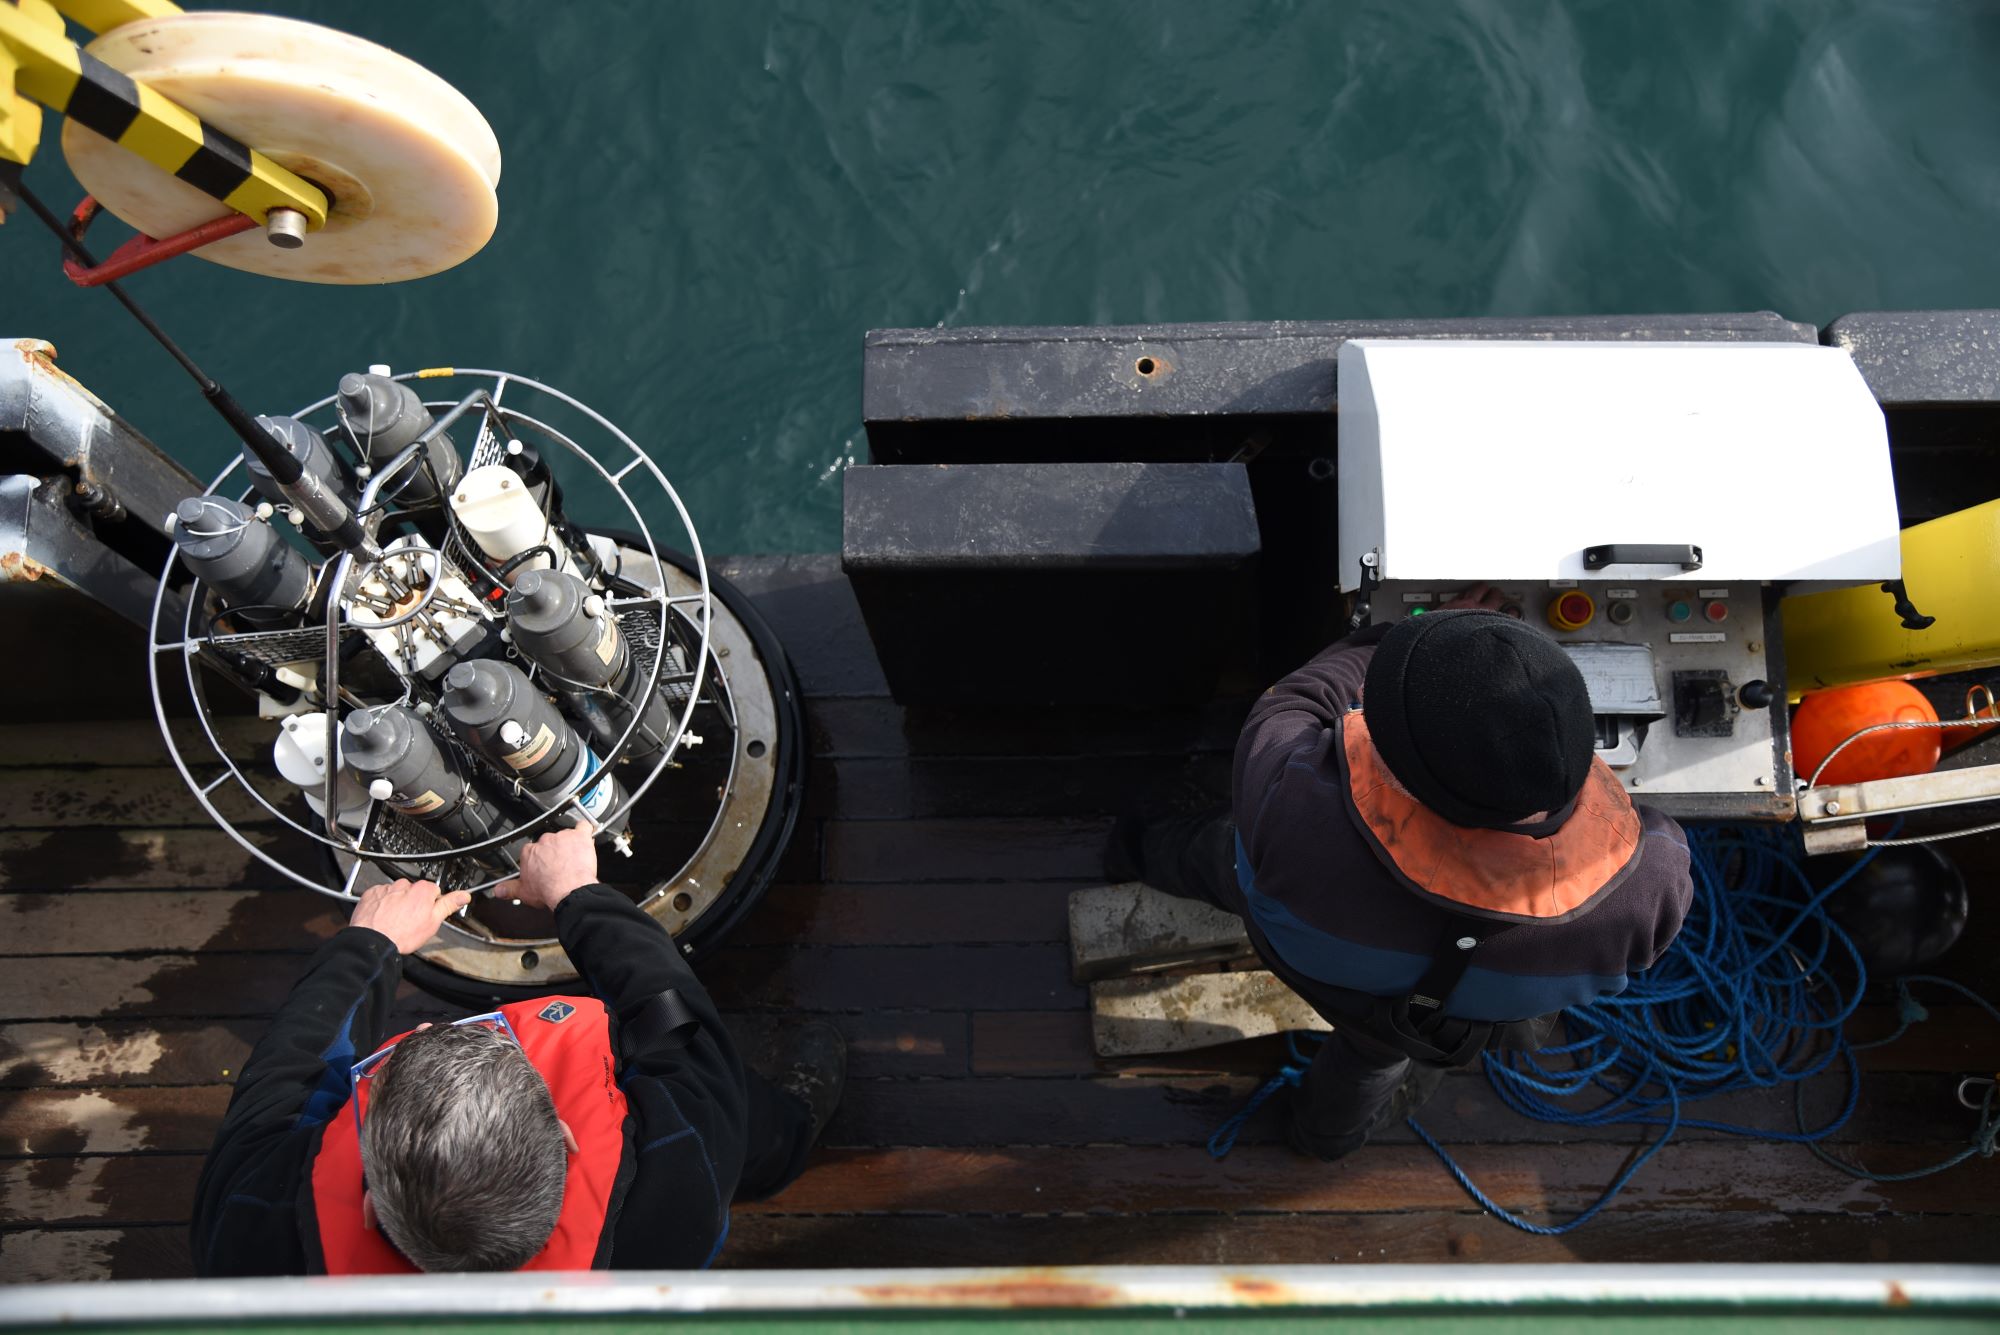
840;464;1258;709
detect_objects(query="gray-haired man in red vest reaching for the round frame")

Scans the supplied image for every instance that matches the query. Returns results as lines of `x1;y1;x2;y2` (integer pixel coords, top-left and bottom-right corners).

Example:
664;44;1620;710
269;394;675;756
192;829;844;1275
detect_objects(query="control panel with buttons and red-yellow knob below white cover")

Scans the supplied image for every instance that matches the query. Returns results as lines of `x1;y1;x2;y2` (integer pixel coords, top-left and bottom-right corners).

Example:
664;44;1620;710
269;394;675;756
1370;580;1792;817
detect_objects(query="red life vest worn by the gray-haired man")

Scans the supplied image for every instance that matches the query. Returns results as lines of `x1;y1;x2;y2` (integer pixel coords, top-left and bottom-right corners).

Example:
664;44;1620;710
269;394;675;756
308;997;626;1275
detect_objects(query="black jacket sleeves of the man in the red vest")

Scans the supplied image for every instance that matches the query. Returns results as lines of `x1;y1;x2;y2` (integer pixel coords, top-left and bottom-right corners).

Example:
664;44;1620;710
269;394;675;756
192;885;780;1277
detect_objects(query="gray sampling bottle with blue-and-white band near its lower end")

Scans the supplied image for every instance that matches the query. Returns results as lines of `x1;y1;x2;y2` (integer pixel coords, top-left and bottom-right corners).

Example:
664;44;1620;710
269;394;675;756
442;658;626;847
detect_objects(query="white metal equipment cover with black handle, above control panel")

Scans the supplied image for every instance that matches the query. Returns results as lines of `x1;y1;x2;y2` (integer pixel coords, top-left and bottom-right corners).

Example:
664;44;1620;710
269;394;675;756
1340;340;1902;590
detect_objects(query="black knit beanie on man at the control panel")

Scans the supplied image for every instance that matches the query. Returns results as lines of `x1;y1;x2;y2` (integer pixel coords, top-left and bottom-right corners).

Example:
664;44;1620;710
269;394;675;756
1362;608;1594;829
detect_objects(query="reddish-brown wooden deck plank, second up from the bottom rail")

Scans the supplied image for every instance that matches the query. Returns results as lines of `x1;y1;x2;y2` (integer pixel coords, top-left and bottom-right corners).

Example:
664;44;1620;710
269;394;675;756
0;1143;2000;1229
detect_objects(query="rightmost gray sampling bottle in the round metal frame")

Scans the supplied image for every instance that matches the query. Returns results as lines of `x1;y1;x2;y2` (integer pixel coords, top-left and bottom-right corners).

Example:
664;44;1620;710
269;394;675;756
506;570;674;759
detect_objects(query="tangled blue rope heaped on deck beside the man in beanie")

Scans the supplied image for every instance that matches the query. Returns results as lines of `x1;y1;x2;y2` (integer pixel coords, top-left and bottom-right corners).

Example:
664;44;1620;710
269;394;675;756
1208;825;2000;1235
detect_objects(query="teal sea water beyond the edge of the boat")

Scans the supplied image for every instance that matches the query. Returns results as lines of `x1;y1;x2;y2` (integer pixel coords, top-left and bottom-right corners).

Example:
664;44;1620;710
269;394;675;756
11;0;2000;552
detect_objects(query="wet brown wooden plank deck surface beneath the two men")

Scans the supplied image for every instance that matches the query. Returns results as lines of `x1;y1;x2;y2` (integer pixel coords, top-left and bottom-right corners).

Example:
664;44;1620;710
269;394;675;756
0;558;2000;1281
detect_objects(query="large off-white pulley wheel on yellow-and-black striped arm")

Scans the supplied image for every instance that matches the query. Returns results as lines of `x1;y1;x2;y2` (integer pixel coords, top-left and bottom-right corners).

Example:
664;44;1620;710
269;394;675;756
62;12;500;284
